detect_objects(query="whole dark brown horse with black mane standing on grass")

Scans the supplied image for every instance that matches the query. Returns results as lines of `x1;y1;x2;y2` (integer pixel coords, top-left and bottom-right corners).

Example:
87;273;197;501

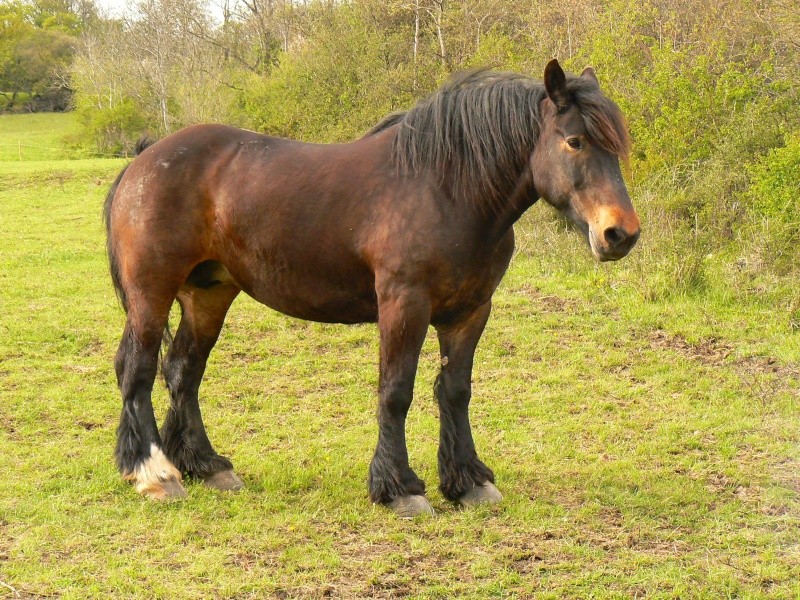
105;60;639;516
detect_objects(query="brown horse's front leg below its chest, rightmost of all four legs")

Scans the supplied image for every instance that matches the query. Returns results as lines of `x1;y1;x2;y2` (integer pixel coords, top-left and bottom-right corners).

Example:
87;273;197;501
434;302;503;506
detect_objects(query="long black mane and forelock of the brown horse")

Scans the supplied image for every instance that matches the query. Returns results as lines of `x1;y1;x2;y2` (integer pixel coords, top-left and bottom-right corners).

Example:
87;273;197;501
388;69;630;211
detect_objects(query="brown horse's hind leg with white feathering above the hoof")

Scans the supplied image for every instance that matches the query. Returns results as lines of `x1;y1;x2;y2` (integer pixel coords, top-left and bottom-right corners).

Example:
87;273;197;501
115;293;186;500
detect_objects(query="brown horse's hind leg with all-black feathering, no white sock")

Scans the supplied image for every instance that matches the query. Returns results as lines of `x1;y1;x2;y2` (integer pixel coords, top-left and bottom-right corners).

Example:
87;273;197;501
161;265;243;491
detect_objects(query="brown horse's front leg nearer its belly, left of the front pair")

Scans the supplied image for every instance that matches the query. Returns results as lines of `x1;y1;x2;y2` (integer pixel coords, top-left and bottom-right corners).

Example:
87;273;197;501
369;289;433;518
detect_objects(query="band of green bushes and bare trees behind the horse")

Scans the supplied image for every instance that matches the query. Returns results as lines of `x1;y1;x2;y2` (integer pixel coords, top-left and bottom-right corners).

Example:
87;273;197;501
0;0;800;328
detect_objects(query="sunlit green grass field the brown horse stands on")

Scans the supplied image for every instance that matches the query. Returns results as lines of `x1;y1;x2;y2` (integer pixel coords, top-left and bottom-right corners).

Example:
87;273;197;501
0;115;800;598
